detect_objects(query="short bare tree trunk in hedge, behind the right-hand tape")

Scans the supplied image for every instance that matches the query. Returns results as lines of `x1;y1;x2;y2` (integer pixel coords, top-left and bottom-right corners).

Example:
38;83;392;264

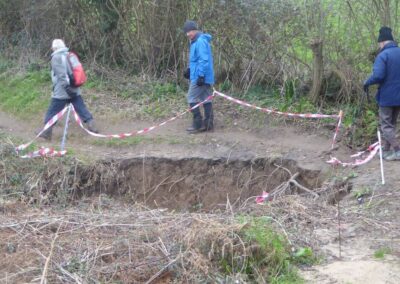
310;39;324;103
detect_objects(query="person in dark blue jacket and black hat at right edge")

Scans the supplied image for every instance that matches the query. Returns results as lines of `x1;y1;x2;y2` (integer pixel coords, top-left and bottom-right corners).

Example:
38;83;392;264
364;27;400;161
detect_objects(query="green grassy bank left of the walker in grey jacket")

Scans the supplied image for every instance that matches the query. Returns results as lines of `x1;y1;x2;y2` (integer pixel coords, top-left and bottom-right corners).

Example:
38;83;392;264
0;70;51;119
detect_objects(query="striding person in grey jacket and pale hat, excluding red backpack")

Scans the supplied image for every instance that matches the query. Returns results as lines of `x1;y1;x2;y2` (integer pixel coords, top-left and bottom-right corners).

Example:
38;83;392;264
40;39;98;140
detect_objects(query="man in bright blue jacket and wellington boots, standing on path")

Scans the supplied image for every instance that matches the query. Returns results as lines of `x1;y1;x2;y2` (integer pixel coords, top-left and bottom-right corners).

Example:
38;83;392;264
183;21;214;133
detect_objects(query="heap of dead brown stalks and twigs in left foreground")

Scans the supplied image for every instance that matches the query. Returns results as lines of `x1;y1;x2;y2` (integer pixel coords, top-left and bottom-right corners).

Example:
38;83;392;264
0;203;248;283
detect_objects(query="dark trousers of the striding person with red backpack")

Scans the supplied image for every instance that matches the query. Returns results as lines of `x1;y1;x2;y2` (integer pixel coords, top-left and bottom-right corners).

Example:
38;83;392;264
44;96;93;124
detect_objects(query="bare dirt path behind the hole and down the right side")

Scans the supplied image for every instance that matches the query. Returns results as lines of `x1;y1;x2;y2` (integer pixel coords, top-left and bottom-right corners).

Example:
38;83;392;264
0;101;400;284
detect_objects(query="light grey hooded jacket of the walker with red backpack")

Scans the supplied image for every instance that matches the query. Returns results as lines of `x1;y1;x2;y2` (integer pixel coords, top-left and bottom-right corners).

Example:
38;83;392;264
51;48;81;100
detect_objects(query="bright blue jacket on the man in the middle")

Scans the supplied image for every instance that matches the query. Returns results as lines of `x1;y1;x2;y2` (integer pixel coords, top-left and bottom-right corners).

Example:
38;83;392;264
189;32;214;85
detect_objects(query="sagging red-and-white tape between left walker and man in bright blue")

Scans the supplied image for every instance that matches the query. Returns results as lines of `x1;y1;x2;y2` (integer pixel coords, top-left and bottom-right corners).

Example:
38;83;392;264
72;94;215;139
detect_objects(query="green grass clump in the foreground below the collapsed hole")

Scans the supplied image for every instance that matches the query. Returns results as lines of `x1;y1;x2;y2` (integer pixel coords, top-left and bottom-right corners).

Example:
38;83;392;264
220;216;315;284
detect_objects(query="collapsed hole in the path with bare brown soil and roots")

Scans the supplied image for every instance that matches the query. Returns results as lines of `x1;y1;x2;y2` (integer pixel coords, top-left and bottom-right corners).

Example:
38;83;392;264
76;157;322;211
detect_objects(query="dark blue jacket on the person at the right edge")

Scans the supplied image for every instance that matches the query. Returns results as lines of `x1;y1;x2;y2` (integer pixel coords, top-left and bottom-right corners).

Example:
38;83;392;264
365;42;400;107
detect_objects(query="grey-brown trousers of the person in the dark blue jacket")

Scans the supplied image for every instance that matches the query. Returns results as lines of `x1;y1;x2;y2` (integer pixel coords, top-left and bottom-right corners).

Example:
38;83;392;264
379;106;400;149
